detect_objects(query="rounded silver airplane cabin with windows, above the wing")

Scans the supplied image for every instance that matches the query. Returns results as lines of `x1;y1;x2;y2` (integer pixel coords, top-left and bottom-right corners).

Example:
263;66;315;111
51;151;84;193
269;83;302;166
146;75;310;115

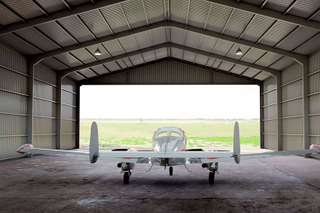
152;126;187;152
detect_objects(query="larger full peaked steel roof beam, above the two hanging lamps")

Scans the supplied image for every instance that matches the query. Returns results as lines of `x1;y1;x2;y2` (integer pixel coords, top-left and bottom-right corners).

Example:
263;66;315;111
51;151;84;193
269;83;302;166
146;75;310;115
30;21;306;65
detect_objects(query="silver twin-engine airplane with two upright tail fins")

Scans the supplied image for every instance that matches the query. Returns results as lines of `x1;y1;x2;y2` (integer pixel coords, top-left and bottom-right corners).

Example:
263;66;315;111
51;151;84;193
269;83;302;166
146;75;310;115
16;122;320;184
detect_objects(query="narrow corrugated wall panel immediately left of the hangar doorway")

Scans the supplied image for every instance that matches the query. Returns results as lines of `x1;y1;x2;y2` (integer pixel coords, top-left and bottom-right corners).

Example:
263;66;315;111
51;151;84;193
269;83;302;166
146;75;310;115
60;78;79;149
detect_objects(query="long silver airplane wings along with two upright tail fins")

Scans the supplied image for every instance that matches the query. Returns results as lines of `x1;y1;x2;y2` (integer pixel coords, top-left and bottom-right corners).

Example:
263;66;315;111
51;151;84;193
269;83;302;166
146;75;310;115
16;122;320;163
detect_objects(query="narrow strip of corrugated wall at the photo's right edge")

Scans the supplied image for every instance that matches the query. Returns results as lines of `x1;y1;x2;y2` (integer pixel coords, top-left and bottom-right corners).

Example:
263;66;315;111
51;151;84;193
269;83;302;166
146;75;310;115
308;51;320;144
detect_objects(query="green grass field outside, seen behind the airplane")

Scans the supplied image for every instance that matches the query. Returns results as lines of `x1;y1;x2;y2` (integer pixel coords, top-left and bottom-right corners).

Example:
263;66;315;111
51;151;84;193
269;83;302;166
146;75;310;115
80;120;260;149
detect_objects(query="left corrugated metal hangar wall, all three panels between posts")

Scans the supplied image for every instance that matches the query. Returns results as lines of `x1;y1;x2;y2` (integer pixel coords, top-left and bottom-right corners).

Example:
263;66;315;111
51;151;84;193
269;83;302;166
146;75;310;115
0;43;79;160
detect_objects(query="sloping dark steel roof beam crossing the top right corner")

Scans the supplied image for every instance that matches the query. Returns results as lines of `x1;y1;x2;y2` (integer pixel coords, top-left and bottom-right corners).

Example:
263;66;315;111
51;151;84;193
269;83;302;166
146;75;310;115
208;0;320;31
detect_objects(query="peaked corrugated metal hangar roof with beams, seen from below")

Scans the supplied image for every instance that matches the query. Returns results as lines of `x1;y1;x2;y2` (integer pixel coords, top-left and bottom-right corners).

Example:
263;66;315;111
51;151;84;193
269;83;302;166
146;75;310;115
0;0;320;81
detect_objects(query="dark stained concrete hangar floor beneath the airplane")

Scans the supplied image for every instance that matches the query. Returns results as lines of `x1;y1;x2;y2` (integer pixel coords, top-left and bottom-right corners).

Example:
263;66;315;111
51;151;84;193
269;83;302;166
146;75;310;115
0;156;320;213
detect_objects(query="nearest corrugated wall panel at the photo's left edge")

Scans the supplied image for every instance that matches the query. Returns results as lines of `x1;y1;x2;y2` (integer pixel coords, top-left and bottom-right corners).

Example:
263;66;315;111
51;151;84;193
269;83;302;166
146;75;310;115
0;43;28;160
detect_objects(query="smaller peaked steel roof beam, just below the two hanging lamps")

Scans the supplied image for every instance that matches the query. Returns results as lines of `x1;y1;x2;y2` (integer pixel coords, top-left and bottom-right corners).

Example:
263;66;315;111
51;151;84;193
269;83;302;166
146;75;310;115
59;43;280;77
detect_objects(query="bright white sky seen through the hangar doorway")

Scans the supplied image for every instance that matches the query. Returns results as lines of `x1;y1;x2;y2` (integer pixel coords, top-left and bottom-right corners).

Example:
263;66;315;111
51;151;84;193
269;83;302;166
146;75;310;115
80;85;260;119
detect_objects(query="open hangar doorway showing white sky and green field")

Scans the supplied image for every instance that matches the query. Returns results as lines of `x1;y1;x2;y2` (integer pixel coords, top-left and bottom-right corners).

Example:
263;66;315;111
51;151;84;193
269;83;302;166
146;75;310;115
80;85;260;149
